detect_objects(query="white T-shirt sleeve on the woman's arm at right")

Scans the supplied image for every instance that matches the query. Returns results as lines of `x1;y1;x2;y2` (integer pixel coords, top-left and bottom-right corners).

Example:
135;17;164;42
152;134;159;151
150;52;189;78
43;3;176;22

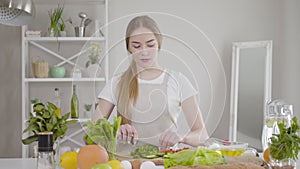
178;73;198;102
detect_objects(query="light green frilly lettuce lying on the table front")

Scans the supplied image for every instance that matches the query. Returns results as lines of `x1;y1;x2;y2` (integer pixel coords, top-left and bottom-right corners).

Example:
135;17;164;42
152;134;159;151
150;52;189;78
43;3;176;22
164;147;226;168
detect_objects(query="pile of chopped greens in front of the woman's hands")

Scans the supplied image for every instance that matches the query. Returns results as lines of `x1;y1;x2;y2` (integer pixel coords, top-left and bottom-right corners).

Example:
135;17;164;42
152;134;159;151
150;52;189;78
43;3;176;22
130;145;159;158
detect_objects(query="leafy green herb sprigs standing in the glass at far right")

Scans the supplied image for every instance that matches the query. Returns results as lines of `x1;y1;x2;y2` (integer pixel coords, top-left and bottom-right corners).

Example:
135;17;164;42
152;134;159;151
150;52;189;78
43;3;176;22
269;117;300;160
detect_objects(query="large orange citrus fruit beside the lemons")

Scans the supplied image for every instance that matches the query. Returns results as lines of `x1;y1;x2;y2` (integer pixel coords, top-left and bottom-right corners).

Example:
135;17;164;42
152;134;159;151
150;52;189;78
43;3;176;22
77;144;108;169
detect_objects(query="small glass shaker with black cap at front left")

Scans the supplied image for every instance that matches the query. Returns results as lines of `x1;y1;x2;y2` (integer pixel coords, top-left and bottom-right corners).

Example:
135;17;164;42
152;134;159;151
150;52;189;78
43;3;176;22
37;132;55;169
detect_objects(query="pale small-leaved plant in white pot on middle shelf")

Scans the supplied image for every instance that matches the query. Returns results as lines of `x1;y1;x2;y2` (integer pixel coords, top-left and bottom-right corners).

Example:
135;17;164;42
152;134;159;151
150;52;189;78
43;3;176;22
85;42;102;77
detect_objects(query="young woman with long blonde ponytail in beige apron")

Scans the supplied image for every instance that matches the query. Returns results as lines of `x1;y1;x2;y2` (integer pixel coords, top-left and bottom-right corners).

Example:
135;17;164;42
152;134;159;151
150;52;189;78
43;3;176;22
93;16;208;149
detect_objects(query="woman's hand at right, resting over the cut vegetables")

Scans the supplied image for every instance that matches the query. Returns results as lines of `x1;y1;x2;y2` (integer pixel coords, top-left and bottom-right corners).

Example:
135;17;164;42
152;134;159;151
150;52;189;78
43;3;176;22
159;131;183;150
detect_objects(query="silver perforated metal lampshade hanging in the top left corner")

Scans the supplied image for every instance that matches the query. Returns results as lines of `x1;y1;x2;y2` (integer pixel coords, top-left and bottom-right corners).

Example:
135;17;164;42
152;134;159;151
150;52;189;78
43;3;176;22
0;0;35;26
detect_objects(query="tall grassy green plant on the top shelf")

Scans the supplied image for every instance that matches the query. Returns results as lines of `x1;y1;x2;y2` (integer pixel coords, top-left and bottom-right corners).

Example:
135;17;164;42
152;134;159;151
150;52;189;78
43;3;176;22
48;4;64;37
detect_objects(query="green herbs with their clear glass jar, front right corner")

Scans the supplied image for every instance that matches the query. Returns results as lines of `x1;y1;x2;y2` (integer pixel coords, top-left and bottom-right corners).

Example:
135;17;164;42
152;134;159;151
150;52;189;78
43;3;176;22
269;117;300;169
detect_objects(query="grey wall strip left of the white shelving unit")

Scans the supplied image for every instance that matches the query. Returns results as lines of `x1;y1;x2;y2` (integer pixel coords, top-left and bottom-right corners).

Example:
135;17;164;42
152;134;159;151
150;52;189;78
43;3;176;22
0;25;22;157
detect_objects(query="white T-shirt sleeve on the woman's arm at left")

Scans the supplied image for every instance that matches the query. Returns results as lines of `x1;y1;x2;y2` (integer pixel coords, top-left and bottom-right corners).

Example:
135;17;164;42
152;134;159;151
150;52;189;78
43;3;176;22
98;77;118;105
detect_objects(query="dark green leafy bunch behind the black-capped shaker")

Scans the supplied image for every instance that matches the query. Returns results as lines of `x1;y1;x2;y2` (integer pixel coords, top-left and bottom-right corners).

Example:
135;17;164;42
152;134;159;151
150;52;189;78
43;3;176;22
22;102;77;145
